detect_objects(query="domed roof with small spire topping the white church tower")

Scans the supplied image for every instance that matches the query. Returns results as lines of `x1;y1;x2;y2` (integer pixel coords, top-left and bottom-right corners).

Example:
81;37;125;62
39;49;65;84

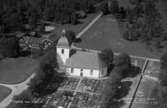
57;29;69;47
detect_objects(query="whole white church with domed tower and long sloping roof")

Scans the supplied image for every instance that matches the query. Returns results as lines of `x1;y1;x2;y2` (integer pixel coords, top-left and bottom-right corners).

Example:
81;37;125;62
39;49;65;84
56;30;107;78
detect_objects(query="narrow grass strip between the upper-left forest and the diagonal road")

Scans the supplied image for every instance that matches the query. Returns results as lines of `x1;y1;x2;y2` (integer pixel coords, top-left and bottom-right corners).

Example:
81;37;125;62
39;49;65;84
50;13;98;40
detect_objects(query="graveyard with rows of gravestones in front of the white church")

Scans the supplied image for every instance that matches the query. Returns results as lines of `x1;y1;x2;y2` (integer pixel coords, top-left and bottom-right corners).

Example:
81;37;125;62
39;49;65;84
43;77;103;108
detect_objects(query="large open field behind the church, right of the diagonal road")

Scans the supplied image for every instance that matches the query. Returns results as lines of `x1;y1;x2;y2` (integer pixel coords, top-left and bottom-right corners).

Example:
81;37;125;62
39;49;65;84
76;15;161;58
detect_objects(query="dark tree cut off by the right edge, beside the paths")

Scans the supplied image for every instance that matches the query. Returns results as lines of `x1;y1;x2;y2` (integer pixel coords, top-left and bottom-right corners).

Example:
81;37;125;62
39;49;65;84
159;53;167;86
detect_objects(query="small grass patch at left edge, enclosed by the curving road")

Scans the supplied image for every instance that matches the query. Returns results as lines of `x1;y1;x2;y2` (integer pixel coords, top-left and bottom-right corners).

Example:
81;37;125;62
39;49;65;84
0;86;11;102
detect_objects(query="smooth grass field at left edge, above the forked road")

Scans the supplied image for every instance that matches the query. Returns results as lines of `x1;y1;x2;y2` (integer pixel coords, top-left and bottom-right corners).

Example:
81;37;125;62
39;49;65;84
0;57;39;84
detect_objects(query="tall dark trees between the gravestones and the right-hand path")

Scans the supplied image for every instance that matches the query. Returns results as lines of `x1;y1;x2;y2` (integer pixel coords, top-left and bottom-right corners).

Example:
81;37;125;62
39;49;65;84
101;53;131;108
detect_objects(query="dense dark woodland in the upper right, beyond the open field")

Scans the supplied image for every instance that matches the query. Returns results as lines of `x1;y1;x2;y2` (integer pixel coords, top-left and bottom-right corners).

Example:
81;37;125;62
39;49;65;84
123;0;165;49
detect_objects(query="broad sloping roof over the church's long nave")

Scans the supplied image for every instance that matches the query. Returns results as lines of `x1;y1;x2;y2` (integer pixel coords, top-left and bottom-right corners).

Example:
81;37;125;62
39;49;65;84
66;51;106;69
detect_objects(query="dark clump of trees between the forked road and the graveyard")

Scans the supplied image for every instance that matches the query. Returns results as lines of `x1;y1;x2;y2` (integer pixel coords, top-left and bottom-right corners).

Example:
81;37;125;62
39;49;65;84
30;64;64;97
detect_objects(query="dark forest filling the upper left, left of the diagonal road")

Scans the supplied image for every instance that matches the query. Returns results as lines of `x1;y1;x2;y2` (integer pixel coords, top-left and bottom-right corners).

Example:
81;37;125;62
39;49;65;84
0;0;101;32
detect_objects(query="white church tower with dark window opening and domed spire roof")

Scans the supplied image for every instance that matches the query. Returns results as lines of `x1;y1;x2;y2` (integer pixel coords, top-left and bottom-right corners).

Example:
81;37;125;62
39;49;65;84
56;30;70;64
